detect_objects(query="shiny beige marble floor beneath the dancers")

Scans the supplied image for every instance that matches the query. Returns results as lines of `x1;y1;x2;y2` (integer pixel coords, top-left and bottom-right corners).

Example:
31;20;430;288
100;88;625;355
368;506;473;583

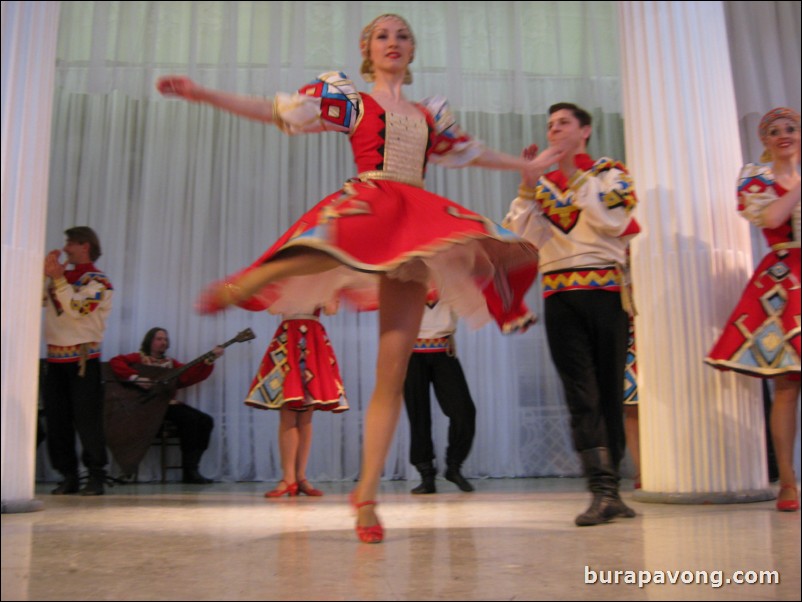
2;479;800;600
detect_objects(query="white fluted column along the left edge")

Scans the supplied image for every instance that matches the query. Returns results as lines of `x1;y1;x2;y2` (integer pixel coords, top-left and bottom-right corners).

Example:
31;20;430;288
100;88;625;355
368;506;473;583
0;2;59;513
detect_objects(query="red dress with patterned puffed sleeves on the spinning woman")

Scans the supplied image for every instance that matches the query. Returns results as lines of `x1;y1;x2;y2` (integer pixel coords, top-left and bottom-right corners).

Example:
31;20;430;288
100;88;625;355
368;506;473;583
214;72;537;332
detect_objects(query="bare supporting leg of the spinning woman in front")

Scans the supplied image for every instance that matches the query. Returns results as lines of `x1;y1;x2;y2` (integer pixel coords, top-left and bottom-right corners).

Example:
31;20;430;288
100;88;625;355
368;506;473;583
353;276;426;527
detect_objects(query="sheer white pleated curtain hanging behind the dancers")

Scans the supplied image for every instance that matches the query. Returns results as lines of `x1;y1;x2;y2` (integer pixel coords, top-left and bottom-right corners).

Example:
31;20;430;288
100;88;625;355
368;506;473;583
38;1;800;480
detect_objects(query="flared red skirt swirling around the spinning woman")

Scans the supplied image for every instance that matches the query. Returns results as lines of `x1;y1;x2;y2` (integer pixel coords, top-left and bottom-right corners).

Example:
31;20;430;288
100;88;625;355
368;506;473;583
223;180;538;332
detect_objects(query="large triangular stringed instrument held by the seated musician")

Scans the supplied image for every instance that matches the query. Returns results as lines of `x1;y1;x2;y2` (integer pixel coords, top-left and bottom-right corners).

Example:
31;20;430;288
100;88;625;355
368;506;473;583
101;328;256;475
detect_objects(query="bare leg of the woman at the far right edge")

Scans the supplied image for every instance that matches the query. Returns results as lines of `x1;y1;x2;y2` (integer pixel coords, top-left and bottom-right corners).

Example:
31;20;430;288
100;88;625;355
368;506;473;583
770;376;800;500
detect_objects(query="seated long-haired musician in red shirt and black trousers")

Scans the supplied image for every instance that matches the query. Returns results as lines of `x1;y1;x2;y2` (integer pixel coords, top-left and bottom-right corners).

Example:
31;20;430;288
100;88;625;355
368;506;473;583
109;327;223;484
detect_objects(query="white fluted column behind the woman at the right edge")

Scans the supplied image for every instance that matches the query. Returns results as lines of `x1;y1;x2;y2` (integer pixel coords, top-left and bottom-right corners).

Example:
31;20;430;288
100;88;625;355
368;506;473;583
619;2;773;503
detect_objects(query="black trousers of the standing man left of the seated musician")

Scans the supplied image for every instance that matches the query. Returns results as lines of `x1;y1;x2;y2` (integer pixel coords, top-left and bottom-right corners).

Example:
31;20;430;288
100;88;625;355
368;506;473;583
43;359;108;475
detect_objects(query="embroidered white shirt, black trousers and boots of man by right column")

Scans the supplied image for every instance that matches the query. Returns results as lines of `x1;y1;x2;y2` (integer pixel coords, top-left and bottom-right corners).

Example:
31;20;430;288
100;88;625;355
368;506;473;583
505;154;640;526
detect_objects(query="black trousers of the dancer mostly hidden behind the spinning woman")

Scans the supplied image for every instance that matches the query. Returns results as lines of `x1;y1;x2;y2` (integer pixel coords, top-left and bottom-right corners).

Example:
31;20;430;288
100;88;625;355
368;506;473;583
404;352;476;467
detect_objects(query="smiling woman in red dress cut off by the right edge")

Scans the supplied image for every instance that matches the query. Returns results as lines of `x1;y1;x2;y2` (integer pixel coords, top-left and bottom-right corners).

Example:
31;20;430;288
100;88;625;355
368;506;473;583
705;107;802;512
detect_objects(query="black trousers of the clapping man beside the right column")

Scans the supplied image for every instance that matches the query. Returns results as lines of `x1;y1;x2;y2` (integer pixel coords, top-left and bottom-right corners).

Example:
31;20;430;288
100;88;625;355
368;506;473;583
544;291;628;466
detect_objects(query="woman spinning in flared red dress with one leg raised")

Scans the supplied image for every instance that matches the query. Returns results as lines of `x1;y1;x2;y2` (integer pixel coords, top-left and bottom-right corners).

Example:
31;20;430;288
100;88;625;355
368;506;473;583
157;15;562;543
